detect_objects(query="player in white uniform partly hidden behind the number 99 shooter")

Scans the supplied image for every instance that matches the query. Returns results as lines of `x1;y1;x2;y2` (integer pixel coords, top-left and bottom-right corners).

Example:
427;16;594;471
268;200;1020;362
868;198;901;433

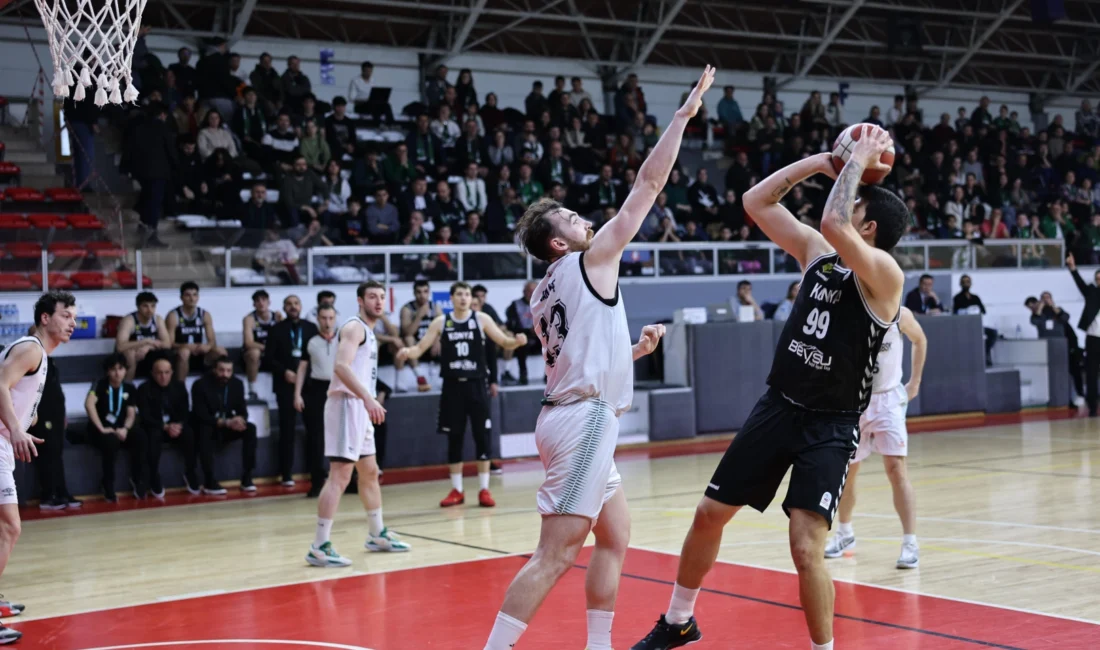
825;307;928;569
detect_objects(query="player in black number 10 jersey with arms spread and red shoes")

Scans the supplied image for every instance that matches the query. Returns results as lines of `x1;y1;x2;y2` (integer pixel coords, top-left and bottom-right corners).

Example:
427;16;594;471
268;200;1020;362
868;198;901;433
397;282;527;508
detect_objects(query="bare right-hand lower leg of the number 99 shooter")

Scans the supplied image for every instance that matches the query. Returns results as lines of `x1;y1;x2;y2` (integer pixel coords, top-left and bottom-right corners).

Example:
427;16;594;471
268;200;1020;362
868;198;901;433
790;508;836;650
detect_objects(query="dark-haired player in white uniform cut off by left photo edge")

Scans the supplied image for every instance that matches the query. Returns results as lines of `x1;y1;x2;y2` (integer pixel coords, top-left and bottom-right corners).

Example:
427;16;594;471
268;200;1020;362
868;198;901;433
0;291;76;645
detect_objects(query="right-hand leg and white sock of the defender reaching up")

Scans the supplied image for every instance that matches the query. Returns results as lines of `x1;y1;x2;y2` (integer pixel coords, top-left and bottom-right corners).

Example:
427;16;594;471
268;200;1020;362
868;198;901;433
584;483;630;650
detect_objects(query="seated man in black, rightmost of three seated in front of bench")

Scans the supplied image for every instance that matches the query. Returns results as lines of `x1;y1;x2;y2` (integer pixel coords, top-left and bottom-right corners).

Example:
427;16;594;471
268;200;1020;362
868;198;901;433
187;356;256;496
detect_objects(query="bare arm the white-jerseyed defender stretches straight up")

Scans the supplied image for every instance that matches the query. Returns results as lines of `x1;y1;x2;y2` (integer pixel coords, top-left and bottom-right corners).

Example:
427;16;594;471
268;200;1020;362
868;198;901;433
584;66;714;271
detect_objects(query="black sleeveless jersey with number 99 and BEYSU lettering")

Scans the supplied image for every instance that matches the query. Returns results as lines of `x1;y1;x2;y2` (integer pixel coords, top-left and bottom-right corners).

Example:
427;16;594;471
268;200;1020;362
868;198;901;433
768;253;898;412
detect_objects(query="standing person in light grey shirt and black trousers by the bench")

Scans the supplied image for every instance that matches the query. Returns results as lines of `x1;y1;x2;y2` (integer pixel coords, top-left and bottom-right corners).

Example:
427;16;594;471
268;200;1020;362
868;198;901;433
294;305;339;498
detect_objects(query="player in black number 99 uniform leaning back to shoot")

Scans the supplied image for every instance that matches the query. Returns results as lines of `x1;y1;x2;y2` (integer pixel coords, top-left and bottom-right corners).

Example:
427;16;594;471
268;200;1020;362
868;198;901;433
631;125;909;650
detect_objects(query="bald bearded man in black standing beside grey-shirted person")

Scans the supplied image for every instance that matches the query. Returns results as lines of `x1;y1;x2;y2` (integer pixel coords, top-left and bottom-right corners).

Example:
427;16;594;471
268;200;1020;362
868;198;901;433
264;296;318;487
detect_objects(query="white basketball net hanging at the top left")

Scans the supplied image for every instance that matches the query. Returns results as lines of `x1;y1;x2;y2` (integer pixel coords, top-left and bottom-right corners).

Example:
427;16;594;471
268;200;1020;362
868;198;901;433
34;0;146;107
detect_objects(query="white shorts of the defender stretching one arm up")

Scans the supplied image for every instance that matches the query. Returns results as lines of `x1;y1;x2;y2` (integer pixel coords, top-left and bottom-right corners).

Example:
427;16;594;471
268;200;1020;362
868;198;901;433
535;399;623;524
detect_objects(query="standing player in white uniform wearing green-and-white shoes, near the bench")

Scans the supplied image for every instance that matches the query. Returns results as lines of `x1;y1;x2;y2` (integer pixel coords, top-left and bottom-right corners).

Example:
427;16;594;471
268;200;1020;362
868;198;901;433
306;280;410;566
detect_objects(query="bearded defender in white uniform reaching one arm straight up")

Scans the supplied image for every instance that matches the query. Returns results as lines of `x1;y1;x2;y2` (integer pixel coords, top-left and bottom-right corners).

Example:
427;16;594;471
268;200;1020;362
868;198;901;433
485;66;714;650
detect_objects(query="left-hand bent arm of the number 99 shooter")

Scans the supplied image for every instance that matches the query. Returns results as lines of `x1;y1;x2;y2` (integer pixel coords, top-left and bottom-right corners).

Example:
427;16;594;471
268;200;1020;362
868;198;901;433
741;153;834;268
